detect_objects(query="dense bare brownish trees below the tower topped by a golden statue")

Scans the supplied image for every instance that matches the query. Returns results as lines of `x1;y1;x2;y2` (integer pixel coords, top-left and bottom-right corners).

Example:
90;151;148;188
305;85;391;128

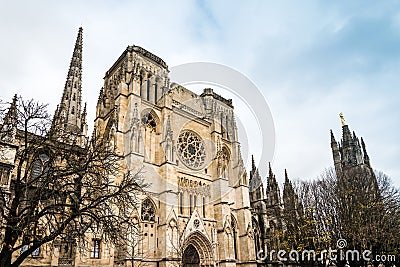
298;168;400;266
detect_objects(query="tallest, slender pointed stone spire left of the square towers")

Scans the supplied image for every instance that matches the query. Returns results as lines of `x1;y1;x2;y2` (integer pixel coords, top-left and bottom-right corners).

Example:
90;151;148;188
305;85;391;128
52;27;87;147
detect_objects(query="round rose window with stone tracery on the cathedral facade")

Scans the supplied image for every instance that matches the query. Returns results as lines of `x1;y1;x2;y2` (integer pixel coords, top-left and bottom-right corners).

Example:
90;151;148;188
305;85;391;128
177;131;206;169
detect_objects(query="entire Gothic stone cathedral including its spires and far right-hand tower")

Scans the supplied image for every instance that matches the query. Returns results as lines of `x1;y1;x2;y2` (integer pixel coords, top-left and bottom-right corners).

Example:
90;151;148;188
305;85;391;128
0;28;378;267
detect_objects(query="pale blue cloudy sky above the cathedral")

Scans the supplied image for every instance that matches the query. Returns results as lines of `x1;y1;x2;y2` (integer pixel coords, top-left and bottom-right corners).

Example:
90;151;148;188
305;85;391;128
0;0;400;187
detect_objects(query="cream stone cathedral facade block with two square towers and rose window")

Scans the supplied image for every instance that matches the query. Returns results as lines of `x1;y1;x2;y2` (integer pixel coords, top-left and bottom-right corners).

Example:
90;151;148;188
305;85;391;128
93;45;256;267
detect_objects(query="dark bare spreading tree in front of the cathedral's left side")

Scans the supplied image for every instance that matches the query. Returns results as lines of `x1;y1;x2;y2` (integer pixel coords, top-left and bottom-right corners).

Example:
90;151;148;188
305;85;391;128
0;98;145;267
